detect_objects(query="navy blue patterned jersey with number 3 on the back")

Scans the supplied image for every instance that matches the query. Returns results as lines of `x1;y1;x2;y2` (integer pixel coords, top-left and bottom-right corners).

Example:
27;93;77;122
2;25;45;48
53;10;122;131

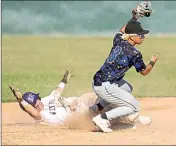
93;33;146;84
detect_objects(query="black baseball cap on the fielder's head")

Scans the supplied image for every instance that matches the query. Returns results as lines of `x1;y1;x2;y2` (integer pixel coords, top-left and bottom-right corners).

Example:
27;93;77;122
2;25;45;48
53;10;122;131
125;21;149;35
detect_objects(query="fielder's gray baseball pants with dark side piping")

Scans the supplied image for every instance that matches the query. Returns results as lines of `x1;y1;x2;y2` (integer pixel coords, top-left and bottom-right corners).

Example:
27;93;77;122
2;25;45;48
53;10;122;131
93;79;139;120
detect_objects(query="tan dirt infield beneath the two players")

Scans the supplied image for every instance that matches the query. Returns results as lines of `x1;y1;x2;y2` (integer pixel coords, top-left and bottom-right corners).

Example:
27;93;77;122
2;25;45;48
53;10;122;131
2;98;176;145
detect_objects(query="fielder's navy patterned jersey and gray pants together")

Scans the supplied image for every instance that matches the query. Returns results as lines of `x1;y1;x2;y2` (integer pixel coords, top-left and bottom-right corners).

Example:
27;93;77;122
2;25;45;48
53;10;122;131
93;29;146;120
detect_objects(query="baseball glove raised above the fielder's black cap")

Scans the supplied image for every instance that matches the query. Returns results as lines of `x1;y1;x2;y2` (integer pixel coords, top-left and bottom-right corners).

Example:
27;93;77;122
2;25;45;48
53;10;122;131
132;2;153;19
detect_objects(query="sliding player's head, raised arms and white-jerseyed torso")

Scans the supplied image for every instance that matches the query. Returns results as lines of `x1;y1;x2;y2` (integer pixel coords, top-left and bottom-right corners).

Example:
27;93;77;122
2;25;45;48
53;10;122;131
9;70;73;125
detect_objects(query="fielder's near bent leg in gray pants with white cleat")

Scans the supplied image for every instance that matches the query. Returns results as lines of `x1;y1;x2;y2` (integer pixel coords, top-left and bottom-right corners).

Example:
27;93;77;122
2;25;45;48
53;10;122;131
93;82;139;132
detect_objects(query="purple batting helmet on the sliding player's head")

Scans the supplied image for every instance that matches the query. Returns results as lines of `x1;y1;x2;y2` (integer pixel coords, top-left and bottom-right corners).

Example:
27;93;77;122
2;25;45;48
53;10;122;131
22;92;41;107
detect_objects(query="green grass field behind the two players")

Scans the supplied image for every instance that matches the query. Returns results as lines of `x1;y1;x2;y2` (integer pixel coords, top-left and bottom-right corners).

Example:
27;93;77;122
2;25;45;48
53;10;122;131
2;36;176;102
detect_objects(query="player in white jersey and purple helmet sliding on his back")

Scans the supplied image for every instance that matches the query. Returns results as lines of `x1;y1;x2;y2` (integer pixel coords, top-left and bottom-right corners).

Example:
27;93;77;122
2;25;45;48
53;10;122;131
9;70;105;125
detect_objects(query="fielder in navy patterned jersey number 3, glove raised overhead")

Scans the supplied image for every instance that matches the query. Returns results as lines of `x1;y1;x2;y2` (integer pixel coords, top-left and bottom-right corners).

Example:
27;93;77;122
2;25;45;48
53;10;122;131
90;2;158;132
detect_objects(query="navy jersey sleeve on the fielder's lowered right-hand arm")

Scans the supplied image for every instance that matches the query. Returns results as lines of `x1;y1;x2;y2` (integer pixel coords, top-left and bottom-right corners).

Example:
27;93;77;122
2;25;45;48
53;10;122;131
132;53;146;72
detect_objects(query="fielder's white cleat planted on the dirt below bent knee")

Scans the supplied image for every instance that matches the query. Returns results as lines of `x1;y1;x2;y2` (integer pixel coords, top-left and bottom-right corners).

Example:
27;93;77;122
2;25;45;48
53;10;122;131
92;114;113;133
